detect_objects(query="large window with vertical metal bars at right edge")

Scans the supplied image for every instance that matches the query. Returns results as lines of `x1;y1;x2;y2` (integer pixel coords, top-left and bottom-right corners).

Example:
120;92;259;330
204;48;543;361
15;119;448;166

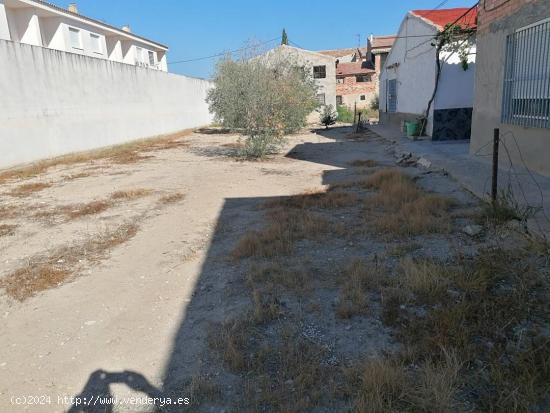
501;21;550;129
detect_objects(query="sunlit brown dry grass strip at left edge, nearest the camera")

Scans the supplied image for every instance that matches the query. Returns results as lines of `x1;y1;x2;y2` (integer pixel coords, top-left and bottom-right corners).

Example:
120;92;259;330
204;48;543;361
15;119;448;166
0;224;137;301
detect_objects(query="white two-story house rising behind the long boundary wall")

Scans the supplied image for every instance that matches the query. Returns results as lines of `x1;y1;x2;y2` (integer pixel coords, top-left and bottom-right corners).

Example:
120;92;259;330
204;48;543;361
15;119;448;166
0;0;168;72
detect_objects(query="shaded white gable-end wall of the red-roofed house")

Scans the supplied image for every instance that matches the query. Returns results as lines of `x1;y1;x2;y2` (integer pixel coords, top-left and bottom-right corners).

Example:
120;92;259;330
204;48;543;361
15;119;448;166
379;13;437;135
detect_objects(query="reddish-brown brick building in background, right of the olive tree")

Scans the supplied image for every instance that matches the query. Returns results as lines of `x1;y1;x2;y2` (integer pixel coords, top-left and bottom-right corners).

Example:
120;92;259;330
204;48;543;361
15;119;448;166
319;36;395;109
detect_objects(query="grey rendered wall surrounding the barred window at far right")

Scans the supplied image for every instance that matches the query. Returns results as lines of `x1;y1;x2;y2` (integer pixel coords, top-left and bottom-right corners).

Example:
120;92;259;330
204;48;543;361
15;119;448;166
470;0;550;176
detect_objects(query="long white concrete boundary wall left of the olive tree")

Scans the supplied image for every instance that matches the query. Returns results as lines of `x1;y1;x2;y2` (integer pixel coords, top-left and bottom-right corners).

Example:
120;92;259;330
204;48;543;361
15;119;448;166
0;40;212;167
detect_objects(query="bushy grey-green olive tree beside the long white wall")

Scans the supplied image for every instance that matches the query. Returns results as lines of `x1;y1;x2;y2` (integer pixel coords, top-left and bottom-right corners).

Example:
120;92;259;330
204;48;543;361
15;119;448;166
207;52;318;158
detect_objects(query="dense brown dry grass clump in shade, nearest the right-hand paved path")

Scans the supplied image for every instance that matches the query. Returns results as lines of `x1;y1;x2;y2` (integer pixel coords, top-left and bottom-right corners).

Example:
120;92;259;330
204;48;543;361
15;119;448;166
366;169;453;236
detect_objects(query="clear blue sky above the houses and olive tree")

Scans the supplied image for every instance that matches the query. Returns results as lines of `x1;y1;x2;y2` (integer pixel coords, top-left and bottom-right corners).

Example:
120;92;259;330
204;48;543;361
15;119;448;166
50;0;475;77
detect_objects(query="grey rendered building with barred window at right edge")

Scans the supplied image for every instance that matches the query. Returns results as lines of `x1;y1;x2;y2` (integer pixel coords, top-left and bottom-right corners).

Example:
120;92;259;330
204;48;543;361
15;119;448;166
470;0;550;176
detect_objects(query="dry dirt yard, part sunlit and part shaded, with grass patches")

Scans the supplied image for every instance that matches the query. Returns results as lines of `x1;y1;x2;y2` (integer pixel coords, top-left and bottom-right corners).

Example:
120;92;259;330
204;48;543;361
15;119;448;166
0;128;550;412
